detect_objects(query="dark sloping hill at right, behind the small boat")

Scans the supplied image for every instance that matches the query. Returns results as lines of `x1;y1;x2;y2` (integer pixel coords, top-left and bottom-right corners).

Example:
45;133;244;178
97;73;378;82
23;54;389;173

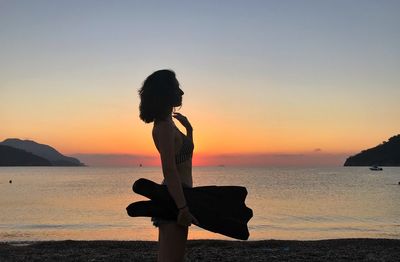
344;135;400;166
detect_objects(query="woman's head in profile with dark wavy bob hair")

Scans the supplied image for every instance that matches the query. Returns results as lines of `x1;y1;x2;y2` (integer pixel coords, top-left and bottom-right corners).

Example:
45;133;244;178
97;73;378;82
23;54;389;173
139;70;183;123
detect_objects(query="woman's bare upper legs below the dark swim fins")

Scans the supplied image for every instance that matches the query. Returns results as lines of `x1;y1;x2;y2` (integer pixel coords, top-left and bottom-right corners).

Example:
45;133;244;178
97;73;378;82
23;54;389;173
158;223;188;262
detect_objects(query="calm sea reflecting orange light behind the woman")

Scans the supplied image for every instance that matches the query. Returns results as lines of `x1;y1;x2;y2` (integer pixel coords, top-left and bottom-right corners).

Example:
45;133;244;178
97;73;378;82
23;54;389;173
0;167;400;241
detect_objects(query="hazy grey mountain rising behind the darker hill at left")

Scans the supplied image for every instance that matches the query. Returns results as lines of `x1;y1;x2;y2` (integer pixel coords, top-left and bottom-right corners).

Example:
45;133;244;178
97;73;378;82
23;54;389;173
0;138;84;166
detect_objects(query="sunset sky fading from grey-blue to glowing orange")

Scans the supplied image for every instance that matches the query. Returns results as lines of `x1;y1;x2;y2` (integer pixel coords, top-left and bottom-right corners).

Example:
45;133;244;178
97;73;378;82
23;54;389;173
0;0;400;166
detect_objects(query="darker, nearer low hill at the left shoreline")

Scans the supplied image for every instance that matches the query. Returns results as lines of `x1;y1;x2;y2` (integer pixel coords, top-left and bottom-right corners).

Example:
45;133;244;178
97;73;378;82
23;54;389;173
0;145;52;166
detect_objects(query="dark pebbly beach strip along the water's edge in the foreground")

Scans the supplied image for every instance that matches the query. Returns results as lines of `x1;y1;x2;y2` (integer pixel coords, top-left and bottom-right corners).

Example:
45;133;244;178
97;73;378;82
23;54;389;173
0;239;400;262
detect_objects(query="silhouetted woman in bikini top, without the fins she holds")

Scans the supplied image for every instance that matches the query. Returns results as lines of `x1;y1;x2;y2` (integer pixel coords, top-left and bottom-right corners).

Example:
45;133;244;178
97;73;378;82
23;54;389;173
139;70;197;261
